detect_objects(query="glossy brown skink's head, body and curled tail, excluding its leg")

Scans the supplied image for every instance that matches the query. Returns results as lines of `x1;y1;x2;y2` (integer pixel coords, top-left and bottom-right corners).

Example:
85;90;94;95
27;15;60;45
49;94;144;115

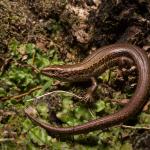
25;44;150;134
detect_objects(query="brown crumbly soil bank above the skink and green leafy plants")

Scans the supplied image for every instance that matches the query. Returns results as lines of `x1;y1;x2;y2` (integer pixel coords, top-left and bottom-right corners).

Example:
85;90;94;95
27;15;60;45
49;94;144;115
0;0;150;56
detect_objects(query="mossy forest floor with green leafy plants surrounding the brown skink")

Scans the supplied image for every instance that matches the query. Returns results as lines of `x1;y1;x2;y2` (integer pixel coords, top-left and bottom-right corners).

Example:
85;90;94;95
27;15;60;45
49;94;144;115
0;0;150;150
